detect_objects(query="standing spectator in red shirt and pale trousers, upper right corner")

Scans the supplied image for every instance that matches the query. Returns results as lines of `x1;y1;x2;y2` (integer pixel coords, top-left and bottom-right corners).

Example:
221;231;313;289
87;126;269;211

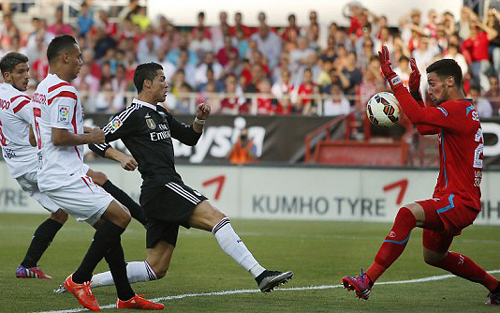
462;19;498;91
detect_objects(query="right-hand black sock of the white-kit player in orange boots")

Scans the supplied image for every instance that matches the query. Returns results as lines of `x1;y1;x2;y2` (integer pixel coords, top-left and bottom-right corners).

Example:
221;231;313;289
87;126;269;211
105;242;135;301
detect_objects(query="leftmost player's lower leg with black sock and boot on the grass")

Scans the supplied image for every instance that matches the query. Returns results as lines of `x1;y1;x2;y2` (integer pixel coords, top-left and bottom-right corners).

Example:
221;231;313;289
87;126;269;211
16;210;68;279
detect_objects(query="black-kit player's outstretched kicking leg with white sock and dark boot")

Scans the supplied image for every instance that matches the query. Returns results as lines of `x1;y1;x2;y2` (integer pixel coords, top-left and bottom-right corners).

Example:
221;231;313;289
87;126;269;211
189;200;293;292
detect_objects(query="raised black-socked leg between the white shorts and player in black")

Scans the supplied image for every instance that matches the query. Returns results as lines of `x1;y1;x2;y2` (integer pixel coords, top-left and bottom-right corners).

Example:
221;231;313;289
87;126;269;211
87;169;148;227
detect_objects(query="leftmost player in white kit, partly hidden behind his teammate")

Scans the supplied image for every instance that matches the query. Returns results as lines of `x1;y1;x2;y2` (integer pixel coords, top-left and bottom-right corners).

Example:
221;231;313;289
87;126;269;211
0;52;147;279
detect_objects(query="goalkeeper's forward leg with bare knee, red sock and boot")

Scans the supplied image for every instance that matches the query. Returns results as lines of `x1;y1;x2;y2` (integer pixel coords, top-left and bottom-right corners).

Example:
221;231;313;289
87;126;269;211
342;203;425;300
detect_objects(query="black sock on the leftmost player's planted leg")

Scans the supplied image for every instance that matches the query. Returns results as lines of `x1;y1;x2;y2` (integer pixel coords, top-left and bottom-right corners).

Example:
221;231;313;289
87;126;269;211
21;218;63;267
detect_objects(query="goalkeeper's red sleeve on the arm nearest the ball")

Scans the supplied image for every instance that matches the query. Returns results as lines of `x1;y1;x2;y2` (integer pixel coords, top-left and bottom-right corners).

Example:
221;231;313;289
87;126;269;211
394;84;460;131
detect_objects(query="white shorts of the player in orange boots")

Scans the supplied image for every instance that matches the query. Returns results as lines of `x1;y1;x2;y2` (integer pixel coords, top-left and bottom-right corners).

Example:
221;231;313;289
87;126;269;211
45;173;114;225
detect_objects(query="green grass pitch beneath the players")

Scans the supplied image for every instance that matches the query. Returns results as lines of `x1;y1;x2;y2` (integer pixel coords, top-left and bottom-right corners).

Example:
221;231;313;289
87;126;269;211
0;214;500;312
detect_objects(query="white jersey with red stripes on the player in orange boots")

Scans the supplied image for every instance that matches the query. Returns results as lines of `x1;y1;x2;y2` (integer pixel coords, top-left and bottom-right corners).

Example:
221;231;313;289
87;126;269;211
32;74;86;191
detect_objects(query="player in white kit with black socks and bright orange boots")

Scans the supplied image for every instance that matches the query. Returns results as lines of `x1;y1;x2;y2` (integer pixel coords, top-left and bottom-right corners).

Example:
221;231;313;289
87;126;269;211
32;35;164;311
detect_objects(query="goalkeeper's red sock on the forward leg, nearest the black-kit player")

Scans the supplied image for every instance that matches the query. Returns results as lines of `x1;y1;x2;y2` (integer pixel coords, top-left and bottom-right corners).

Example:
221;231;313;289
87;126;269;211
366;207;417;283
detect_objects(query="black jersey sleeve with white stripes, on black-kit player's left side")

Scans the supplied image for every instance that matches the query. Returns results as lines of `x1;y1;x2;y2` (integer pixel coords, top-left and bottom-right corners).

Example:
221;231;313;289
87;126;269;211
102;108;141;142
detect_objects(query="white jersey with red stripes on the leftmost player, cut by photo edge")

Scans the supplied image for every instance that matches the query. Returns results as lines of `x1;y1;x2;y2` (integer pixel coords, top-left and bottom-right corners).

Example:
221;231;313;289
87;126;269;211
0;83;38;178
